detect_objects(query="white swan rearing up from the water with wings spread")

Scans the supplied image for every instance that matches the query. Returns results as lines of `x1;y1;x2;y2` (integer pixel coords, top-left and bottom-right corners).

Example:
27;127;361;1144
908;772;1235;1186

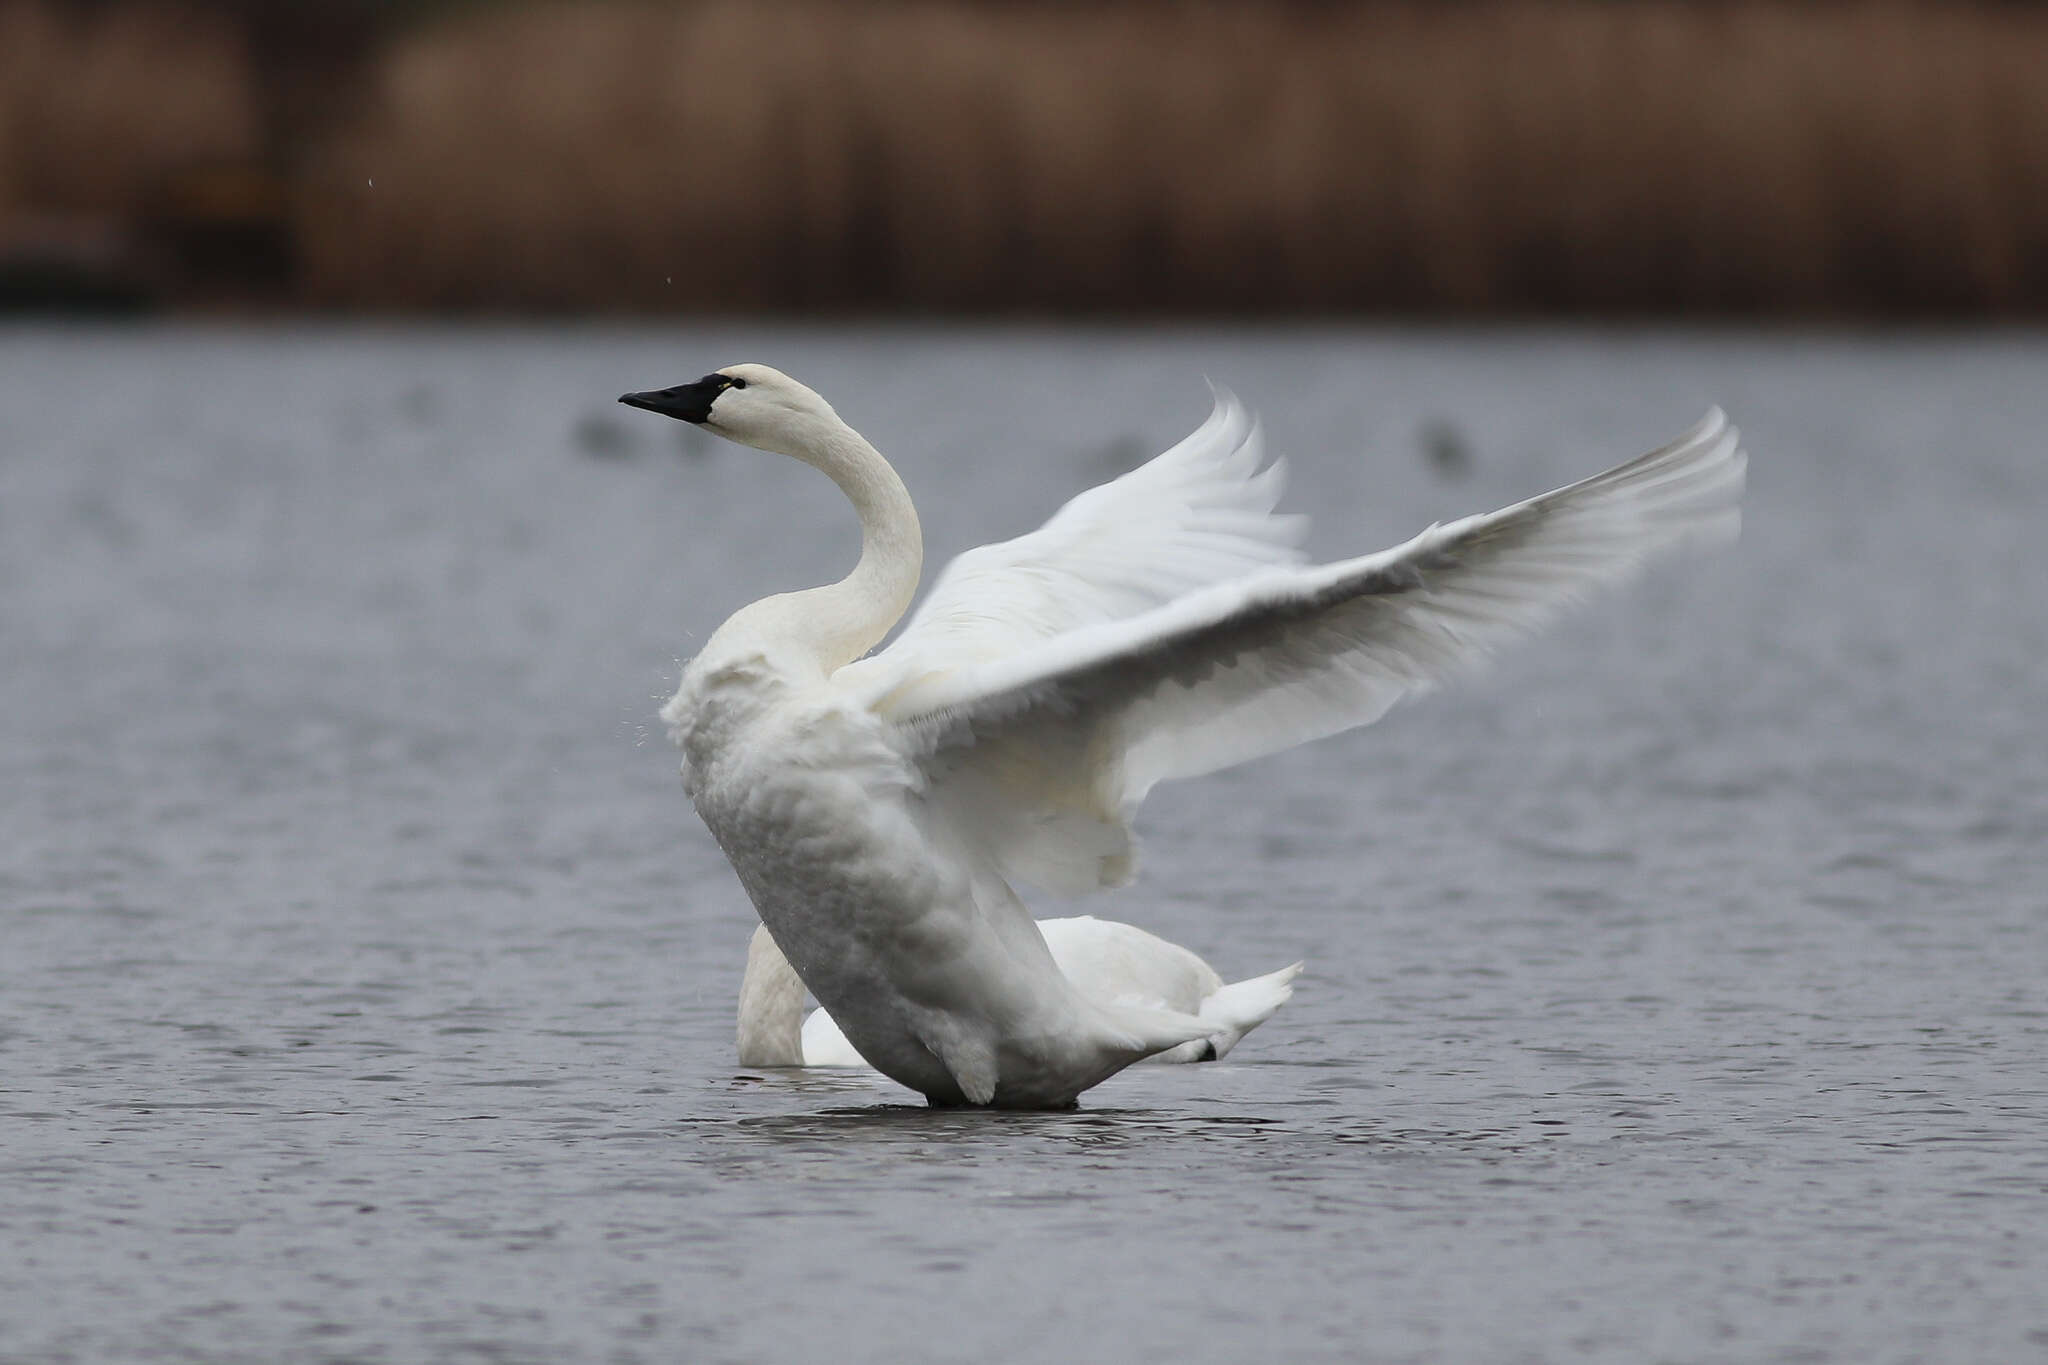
621;364;1745;1109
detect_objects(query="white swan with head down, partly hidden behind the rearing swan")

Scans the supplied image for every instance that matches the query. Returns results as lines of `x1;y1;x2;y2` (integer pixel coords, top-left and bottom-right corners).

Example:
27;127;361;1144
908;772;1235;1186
739;915;1300;1066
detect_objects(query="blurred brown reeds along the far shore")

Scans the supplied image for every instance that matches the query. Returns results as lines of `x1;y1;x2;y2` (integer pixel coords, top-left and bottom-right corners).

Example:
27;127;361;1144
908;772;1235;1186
0;0;2048;319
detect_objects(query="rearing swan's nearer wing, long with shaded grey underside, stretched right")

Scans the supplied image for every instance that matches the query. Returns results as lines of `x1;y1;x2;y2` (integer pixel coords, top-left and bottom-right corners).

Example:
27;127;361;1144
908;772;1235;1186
874;409;1745;890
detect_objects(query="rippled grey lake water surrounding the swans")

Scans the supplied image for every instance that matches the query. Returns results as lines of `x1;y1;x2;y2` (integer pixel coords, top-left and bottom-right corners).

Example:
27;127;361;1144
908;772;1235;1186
0;325;2048;1365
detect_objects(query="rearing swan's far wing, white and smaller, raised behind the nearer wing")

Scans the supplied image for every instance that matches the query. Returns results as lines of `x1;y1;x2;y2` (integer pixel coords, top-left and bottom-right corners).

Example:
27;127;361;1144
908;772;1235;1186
844;389;1305;699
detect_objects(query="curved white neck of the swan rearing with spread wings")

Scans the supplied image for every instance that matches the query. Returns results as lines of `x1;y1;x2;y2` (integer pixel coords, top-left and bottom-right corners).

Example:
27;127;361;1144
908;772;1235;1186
729;415;924;673
